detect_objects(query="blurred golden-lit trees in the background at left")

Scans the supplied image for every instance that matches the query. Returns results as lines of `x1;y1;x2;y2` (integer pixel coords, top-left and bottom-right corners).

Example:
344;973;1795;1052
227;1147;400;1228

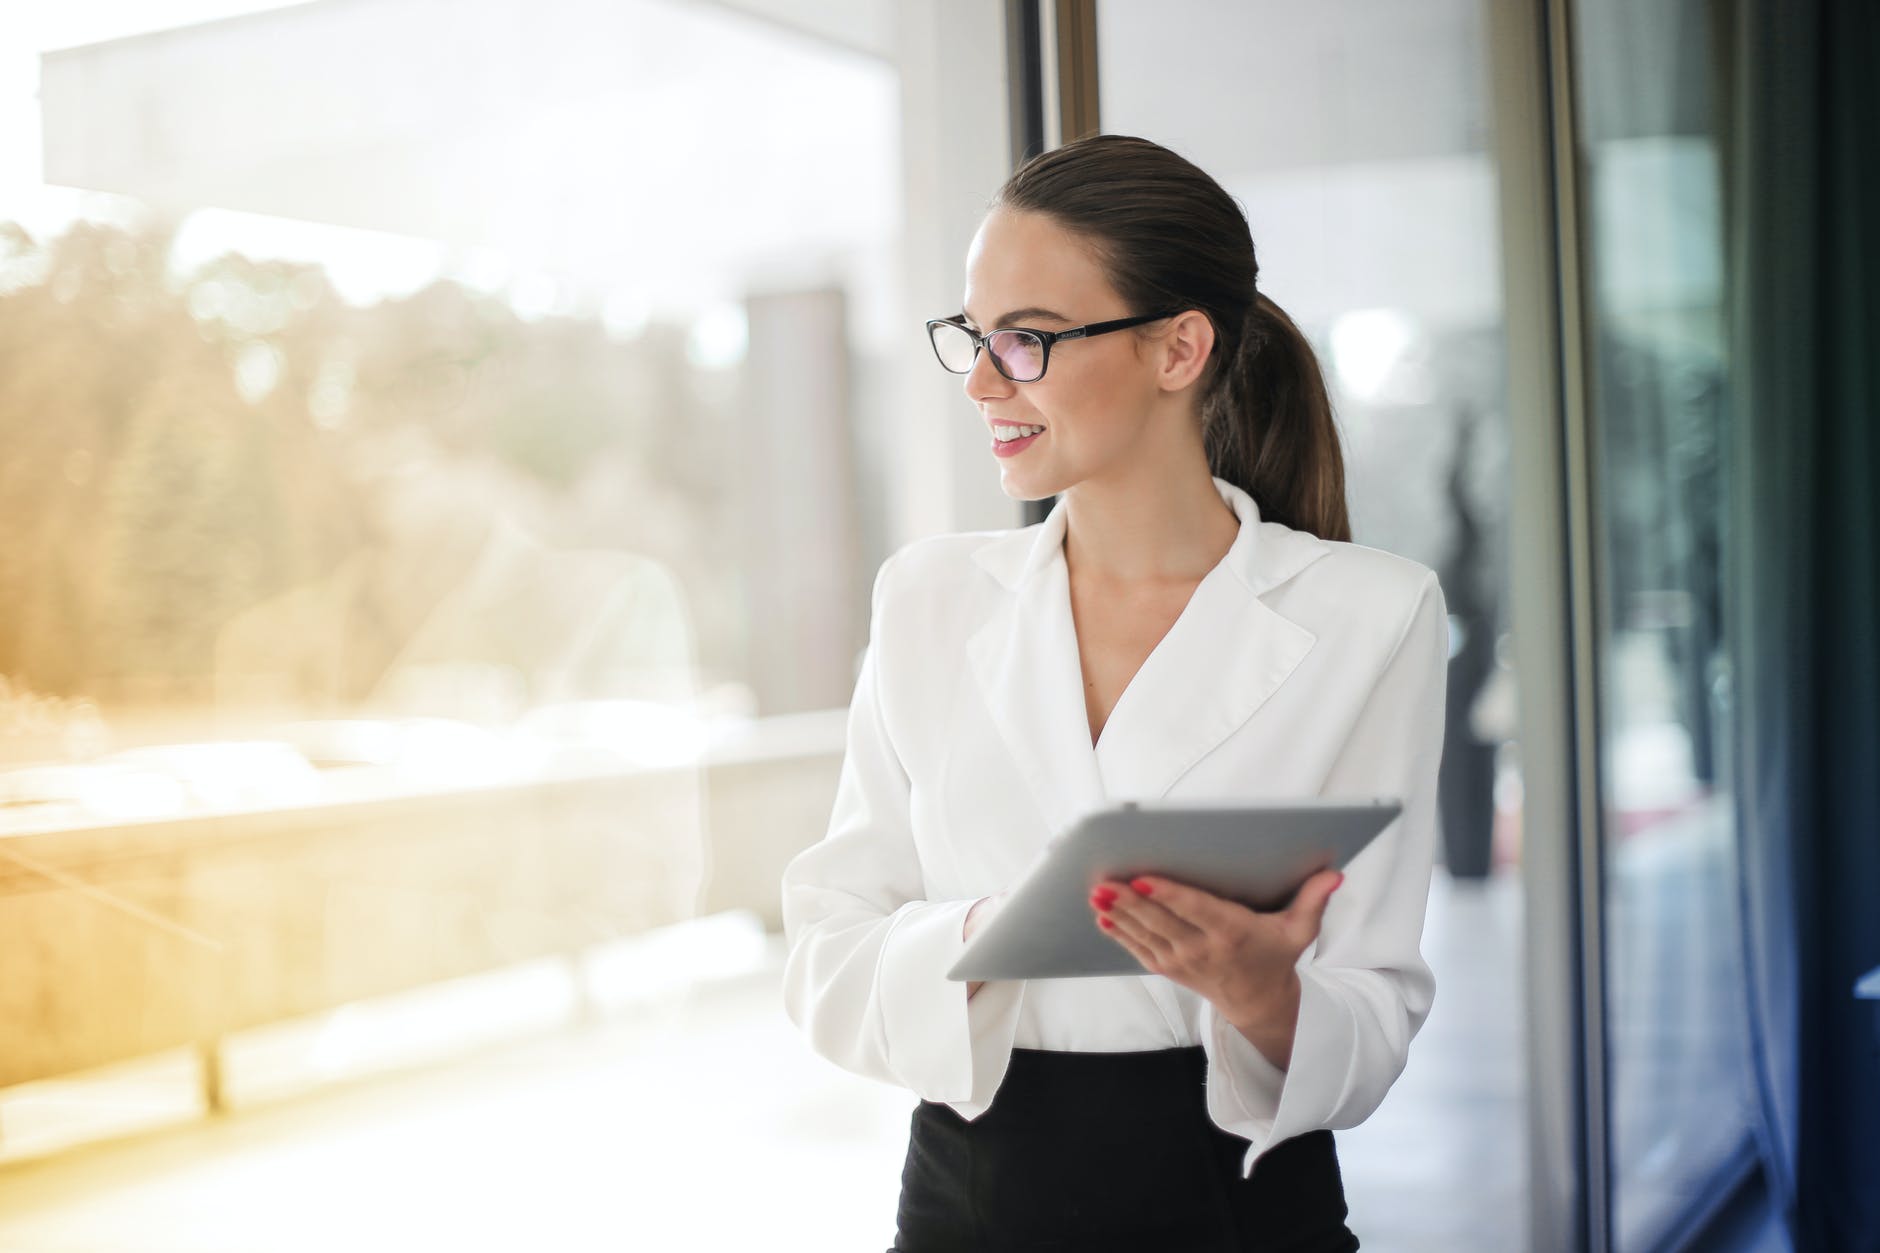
0;209;737;700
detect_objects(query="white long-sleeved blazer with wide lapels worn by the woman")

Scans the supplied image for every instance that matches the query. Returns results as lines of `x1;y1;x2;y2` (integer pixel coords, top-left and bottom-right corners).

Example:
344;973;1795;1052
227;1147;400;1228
782;478;1449;1176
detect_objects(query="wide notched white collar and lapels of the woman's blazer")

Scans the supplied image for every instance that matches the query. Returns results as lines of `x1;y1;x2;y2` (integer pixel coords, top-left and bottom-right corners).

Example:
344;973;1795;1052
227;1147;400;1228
966;476;1331;837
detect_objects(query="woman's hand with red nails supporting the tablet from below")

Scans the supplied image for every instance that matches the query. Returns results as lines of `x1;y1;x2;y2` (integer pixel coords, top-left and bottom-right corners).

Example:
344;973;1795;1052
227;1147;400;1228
1090;869;1344;1037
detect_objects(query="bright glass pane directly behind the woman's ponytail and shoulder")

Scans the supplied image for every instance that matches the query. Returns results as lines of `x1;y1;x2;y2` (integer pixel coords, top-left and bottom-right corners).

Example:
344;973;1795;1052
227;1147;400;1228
1098;0;1527;1249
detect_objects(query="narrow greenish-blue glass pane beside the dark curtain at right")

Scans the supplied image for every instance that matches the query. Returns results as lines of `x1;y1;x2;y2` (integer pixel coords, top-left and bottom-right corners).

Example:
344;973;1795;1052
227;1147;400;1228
1575;0;1750;1249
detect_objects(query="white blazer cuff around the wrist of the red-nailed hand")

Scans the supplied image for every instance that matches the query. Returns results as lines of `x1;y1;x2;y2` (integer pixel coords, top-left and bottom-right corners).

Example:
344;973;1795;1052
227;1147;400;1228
1201;965;1357;1176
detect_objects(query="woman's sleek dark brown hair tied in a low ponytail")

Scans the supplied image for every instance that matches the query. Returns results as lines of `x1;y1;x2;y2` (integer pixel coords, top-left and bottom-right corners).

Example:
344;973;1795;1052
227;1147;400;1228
989;135;1352;540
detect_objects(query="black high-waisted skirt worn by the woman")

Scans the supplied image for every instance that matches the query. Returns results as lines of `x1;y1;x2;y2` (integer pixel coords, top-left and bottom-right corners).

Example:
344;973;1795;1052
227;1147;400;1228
891;1044;1357;1253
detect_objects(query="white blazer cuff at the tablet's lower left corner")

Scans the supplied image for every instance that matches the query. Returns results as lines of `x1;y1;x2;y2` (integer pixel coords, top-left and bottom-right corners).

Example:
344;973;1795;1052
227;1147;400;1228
876;901;1025;1119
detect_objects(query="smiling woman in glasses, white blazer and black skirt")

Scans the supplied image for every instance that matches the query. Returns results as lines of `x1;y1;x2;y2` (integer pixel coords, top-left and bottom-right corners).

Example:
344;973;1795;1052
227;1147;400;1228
782;135;1448;1251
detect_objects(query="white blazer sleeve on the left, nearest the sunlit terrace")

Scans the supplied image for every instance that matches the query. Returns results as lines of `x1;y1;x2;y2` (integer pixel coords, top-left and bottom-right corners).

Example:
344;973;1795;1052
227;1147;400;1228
782;545;1023;1118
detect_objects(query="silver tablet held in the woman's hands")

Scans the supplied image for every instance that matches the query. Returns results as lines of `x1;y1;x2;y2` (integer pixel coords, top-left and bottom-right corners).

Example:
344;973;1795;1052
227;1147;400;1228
948;800;1402;980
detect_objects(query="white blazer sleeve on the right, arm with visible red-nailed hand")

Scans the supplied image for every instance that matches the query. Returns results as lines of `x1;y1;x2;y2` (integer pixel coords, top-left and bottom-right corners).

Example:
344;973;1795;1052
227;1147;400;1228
1199;572;1449;1176
